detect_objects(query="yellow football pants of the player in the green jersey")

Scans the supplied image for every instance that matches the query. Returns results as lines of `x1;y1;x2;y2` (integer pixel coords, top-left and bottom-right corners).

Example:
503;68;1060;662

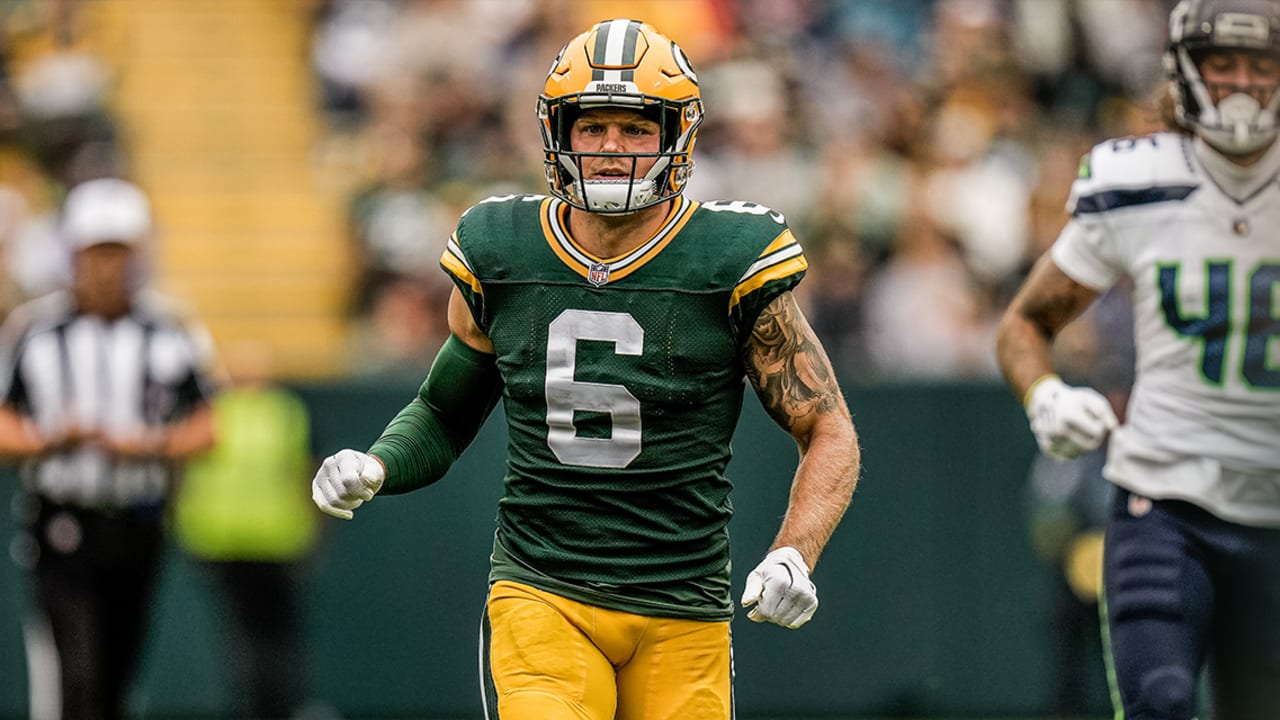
489;580;732;720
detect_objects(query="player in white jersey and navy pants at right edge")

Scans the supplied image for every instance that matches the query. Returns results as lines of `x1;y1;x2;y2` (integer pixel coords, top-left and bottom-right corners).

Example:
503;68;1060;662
997;0;1280;720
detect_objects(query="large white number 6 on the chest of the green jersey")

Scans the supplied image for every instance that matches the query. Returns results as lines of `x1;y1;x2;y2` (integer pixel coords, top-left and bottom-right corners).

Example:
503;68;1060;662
545;309;644;469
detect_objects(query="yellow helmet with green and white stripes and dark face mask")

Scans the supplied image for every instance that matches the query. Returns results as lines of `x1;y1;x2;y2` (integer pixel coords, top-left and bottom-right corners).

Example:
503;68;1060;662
538;19;703;215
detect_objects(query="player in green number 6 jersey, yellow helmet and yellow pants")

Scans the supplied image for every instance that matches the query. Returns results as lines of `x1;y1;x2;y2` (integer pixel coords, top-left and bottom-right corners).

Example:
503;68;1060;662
314;19;859;720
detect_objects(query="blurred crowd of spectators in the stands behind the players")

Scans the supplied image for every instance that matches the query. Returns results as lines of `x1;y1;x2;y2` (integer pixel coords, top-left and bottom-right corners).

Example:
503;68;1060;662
0;0;1171;382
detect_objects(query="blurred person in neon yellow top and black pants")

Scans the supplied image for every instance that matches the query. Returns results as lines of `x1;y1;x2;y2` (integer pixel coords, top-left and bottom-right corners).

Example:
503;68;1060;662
174;342;319;719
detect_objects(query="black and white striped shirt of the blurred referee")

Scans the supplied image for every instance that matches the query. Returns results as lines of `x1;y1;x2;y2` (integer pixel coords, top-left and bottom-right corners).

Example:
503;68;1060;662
0;291;214;509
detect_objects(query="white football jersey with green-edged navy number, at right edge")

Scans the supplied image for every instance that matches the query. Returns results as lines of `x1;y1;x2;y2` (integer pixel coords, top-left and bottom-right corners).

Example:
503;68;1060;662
1051;133;1280;527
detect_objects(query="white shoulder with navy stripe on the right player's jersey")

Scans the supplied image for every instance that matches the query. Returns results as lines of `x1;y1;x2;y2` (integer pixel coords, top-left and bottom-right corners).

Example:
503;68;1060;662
1068;132;1202;215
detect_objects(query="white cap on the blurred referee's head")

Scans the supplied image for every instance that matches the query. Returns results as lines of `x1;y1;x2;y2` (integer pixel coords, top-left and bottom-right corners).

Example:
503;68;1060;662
63;178;151;250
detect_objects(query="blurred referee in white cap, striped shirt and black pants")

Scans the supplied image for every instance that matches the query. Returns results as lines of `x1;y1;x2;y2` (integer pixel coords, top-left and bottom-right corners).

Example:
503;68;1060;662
0;178;214;720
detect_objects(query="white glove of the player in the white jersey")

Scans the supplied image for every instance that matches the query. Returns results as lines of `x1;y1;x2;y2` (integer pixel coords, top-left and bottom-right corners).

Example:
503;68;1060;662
1027;375;1119;460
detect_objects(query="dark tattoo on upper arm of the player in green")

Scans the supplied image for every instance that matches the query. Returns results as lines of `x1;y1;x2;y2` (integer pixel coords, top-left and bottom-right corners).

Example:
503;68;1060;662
746;293;840;429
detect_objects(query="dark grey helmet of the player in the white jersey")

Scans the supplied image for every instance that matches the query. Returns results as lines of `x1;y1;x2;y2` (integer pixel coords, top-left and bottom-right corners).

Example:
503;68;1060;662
1165;0;1280;155
